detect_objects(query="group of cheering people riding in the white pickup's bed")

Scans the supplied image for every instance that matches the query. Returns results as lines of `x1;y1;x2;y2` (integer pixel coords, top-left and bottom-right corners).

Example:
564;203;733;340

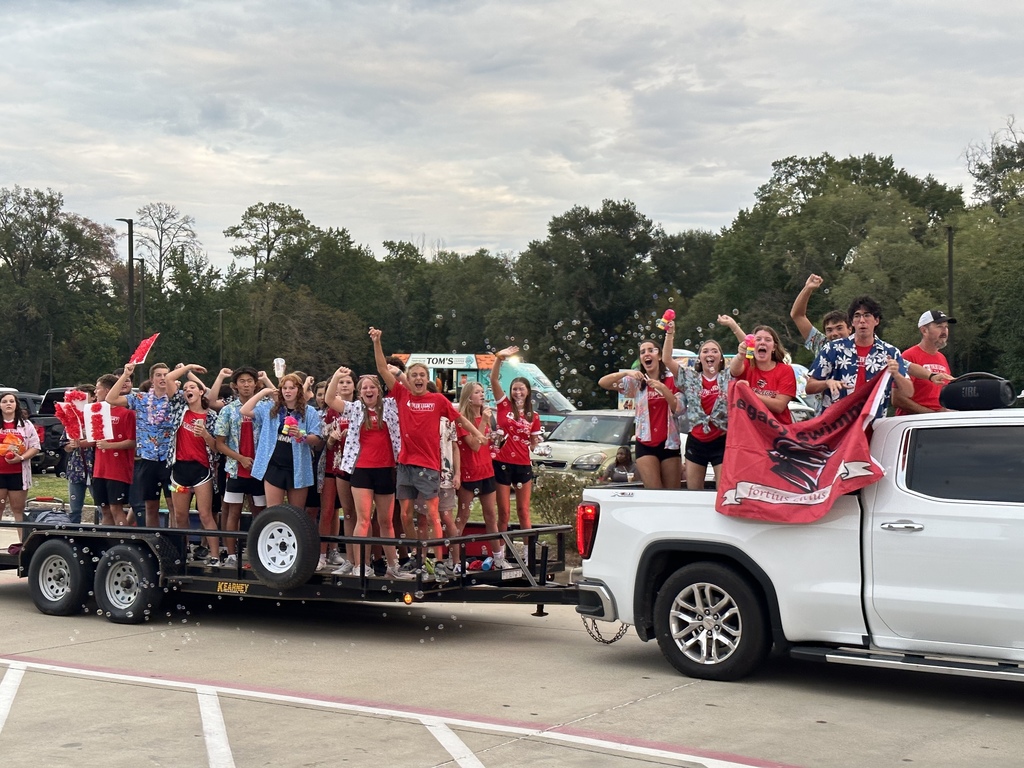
598;274;956;489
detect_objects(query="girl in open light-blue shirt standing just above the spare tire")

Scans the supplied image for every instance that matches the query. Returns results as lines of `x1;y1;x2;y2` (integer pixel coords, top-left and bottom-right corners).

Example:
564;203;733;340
242;374;322;509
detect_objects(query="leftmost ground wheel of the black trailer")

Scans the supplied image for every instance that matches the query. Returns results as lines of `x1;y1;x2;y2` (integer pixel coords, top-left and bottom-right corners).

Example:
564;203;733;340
29;539;92;616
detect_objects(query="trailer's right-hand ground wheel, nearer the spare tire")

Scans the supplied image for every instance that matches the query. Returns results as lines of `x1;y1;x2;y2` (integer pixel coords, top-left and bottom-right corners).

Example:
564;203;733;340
94;544;164;624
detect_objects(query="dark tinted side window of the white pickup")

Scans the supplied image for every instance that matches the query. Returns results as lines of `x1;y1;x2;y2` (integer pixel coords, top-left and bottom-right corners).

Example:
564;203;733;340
906;426;1024;503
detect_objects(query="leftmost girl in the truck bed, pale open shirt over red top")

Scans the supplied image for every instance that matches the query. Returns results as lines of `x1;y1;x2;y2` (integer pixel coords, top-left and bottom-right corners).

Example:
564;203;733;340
597;341;682;488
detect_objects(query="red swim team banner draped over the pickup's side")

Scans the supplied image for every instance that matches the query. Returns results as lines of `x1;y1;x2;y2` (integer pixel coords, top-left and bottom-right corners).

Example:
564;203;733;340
715;372;890;522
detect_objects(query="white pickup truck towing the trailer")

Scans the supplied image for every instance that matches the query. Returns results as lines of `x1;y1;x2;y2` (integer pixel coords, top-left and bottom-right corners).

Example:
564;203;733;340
577;409;1024;680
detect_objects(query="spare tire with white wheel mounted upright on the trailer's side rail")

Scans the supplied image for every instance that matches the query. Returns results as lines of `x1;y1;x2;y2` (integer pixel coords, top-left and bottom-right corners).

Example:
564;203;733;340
246;504;319;590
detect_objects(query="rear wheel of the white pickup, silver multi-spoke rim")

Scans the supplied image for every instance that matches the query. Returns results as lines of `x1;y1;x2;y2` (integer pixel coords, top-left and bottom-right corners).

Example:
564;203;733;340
654;562;771;680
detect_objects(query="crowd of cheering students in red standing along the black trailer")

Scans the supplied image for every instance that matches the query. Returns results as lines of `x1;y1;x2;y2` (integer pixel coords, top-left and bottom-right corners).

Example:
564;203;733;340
0;328;542;581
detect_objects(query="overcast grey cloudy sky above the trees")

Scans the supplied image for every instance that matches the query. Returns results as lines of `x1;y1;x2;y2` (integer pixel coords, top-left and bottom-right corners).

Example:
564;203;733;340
0;0;1024;266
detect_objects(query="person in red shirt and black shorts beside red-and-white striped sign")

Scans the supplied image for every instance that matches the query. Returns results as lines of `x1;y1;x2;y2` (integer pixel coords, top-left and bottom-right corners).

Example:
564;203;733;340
92;374;141;525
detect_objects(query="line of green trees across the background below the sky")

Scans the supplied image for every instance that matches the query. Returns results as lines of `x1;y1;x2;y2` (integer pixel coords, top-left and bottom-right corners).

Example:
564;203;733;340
0;120;1024;407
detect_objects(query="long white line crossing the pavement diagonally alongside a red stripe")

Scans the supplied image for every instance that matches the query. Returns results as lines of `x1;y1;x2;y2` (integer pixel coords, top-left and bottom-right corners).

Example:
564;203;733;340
0;657;777;768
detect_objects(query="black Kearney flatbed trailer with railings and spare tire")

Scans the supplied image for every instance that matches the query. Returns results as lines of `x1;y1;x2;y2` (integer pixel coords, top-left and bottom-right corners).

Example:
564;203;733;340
0;505;578;624
